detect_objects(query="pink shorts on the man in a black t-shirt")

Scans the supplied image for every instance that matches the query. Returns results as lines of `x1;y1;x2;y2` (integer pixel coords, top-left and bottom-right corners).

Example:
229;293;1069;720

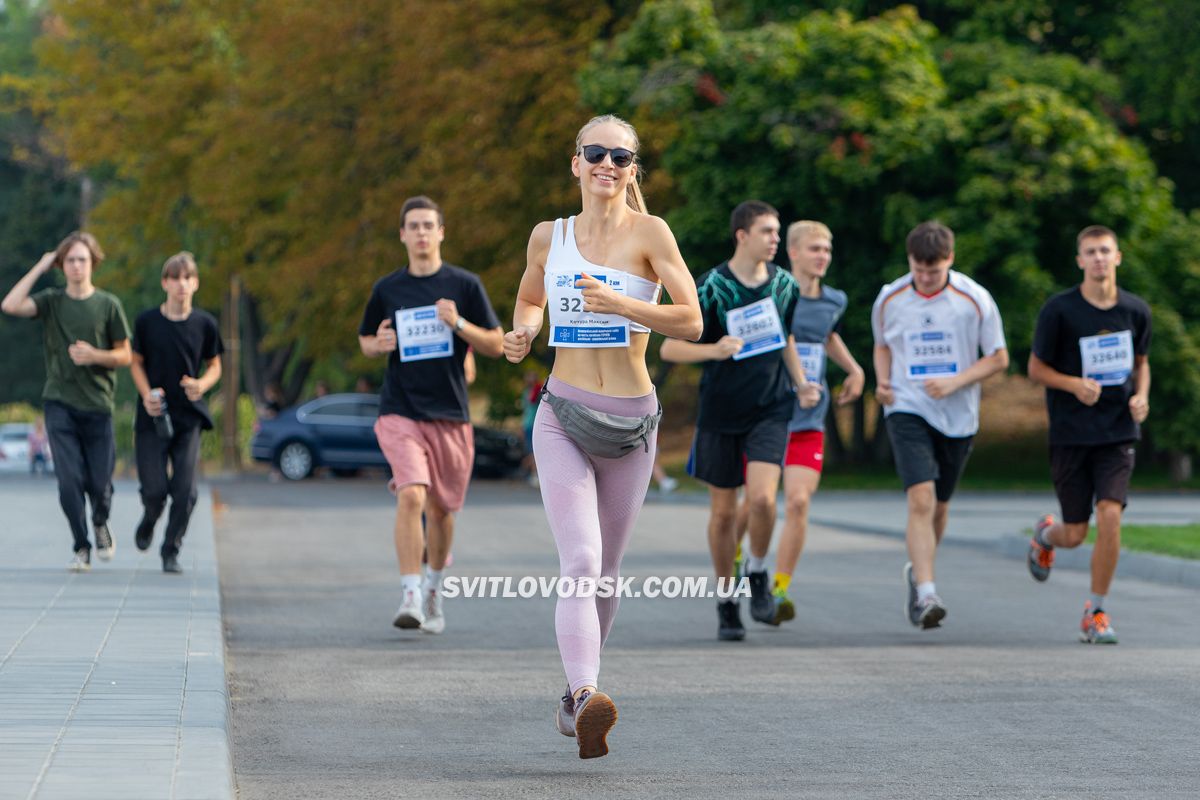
376;414;475;512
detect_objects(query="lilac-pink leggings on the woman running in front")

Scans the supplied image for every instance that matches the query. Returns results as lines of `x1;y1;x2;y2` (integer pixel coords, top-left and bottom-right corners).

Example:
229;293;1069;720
533;375;658;692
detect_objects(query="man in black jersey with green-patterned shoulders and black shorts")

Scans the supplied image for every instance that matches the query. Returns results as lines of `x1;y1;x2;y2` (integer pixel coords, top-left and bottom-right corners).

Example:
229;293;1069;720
661;200;821;640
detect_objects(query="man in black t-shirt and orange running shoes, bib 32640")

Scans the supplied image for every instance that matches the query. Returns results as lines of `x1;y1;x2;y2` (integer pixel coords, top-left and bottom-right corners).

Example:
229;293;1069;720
1028;225;1151;644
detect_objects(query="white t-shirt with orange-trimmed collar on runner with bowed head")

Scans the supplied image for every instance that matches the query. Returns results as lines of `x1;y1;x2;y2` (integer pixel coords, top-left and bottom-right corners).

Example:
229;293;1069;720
871;270;1006;437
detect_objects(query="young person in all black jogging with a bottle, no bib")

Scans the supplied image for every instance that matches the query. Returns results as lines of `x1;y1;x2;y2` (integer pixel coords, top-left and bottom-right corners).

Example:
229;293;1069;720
130;251;224;575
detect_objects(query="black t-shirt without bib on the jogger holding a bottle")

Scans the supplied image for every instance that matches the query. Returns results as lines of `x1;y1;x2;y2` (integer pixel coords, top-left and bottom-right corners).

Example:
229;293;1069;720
131;308;224;431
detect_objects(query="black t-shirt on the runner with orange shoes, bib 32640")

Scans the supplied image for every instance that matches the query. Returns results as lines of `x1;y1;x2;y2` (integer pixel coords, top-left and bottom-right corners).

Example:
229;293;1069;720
1033;287;1150;445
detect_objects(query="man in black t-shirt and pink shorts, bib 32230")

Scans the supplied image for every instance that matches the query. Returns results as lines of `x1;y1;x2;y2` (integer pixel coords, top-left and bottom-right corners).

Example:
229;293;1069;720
359;191;504;633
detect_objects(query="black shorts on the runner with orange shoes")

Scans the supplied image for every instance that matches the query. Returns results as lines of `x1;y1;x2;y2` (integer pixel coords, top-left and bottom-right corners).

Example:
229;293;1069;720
1050;441;1135;522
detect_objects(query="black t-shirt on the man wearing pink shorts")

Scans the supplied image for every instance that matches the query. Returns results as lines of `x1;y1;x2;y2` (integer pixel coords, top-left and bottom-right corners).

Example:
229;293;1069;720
359;264;500;422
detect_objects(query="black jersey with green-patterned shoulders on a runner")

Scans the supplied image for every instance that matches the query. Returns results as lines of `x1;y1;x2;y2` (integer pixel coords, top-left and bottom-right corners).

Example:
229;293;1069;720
696;261;800;433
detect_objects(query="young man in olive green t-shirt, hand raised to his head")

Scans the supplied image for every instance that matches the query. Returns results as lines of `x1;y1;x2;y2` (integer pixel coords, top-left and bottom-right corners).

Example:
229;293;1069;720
0;231;132;572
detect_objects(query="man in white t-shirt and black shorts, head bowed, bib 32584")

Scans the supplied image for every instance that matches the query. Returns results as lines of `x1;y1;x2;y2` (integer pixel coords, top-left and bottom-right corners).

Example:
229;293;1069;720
871;221;1008;628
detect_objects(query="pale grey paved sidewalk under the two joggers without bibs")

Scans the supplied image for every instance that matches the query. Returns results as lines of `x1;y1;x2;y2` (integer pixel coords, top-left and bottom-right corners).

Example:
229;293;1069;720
0;476;234;800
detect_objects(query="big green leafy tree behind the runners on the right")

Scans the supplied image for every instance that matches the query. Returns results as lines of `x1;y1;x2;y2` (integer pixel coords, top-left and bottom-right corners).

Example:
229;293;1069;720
581;0;1200;455
